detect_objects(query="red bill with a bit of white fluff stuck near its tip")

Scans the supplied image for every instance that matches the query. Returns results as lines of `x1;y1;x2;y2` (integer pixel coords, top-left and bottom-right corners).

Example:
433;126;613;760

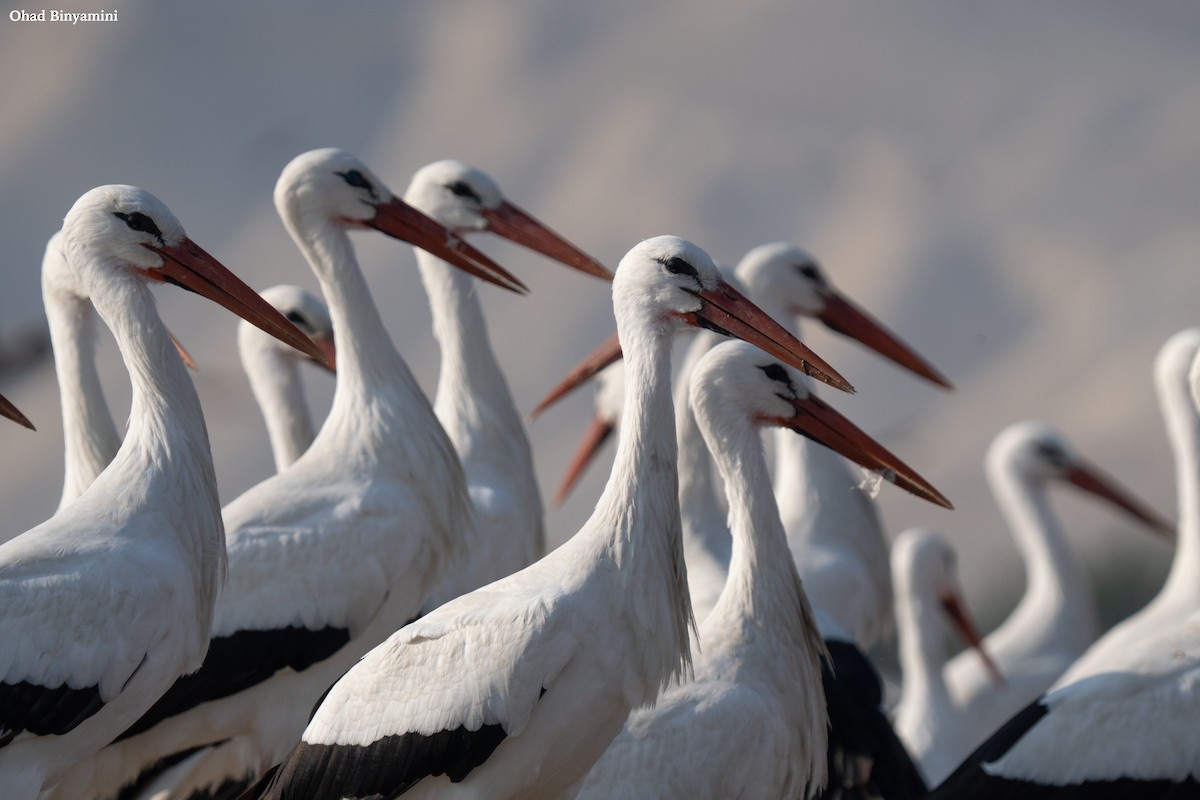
766;395;954;509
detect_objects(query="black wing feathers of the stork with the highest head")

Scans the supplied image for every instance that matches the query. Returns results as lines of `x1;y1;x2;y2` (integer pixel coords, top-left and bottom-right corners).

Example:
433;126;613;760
116;626;350;741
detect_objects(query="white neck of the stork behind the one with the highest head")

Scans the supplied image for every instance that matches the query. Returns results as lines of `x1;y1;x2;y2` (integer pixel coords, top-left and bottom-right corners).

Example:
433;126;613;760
416;249;533;474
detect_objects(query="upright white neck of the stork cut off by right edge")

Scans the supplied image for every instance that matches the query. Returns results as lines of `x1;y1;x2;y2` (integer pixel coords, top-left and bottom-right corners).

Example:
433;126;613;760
1159;367;1200;597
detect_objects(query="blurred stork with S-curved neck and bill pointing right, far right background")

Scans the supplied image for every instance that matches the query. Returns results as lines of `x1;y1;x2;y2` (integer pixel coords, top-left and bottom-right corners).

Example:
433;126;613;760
918;422;1171;784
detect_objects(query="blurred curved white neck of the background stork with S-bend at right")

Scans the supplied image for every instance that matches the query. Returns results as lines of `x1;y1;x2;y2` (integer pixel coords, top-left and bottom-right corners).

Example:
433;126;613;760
988;462;1098;633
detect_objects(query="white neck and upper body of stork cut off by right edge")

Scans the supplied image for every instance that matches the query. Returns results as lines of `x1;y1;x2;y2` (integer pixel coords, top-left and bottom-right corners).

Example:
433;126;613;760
1055;327;1200;686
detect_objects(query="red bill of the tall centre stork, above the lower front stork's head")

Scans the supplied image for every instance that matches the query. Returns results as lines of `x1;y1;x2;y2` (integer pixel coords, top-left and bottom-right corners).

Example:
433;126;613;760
680;281;854;392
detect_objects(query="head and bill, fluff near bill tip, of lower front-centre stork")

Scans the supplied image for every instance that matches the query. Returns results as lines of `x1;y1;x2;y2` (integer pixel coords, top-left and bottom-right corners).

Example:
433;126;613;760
690;342;953;509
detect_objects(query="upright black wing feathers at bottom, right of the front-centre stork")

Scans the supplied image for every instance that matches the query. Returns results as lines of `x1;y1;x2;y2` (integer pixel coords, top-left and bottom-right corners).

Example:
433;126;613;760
820;639;929;800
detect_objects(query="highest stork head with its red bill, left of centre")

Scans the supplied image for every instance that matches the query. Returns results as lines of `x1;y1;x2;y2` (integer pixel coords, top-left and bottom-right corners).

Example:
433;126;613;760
275;148;526;291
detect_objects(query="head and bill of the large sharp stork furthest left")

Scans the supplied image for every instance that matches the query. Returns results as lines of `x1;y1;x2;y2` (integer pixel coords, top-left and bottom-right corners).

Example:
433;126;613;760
62;186;324;361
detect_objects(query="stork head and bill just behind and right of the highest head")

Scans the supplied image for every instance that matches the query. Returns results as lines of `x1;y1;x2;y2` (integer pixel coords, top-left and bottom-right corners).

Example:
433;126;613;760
404;160;612;281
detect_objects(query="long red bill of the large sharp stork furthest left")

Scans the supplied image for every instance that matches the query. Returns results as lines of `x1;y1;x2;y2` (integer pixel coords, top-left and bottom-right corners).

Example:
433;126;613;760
143;239;325;371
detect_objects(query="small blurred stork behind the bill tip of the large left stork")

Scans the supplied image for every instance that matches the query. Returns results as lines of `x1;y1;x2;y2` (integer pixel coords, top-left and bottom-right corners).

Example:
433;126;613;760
238;283;337;473
